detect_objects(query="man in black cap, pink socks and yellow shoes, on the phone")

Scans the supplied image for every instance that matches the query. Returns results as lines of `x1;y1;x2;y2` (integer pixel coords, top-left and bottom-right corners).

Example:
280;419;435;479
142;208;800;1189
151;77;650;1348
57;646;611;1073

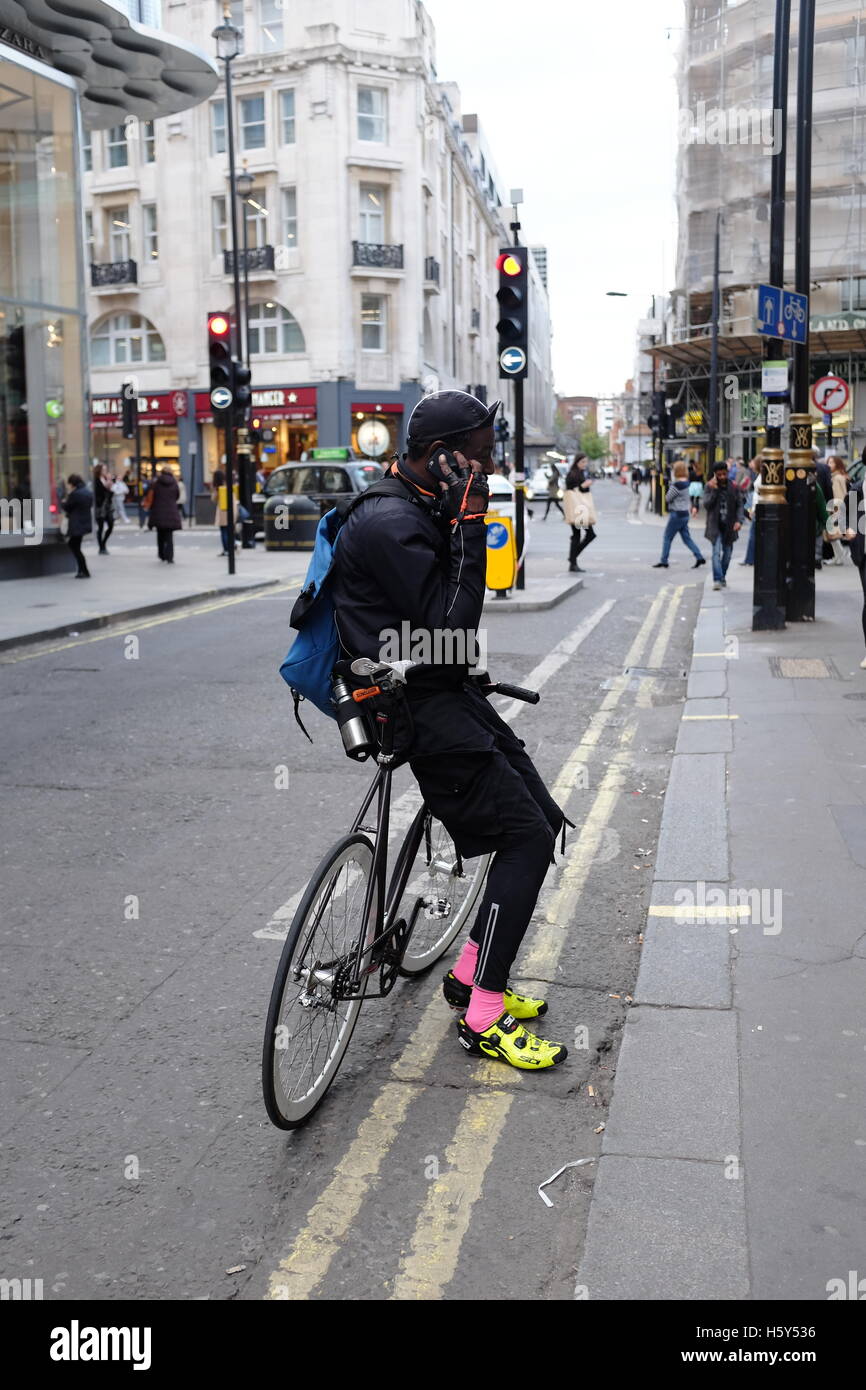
332;391;570;1070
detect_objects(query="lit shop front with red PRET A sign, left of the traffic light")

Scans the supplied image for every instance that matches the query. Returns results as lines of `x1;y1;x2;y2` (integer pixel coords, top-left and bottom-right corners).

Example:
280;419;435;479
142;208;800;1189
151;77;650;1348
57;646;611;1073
90;391;188;503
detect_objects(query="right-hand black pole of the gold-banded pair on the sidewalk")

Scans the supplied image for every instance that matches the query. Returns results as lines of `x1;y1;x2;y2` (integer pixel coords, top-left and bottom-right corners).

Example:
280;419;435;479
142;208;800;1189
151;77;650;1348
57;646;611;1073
785;0;815;623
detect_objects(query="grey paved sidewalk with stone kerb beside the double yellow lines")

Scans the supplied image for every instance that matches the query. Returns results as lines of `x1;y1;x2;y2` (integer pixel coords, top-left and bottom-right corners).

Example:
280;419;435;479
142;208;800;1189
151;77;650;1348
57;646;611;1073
578;564;866;1300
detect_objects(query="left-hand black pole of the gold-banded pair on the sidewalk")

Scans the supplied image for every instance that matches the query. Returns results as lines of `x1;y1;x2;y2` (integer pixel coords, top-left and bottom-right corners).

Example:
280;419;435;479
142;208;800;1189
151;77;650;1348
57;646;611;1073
752;0;791;632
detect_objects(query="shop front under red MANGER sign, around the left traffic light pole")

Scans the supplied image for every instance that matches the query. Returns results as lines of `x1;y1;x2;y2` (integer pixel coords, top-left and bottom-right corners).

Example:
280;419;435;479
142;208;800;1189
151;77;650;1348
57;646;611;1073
195;386;318;484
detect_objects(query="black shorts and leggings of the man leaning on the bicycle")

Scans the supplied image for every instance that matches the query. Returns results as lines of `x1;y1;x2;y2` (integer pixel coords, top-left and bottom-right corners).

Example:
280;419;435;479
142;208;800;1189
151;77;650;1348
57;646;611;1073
411;689;564;991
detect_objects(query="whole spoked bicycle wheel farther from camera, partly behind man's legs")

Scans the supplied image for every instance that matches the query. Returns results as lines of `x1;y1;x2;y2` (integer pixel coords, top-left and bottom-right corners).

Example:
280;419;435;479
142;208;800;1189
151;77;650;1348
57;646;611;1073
389;806;492;977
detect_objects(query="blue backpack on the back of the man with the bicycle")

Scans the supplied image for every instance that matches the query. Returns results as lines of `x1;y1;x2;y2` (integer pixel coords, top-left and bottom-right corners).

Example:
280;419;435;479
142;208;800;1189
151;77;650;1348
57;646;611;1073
279;478;421;742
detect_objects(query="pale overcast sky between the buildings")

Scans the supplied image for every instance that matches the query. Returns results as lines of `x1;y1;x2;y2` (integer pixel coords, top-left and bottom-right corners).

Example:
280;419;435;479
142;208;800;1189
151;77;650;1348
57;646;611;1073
425;0;684;395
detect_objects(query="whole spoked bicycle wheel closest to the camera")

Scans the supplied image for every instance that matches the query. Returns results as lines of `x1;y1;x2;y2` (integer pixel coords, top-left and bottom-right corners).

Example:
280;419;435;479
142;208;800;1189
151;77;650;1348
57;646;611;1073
261;834;378;1129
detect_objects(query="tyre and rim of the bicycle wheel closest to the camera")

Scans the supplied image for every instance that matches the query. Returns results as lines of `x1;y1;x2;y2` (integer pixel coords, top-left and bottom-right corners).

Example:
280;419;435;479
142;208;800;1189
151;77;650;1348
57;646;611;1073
261;834;378;1130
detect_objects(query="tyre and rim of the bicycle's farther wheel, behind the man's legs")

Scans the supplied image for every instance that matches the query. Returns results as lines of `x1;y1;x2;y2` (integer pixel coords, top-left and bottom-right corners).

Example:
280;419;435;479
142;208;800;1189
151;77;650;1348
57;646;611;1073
386;806;492;980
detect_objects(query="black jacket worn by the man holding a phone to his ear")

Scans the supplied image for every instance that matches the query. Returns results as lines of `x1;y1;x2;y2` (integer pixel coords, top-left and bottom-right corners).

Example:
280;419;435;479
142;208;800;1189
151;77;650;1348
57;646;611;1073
331;485;487;695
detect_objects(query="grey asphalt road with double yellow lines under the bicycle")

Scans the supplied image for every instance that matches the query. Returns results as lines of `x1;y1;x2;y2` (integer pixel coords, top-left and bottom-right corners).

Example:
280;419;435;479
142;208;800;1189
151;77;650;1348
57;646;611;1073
0;482;703;1300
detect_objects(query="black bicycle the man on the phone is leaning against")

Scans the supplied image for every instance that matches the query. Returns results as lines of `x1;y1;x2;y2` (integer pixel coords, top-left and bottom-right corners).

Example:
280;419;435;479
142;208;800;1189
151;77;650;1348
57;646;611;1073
261;657;539;1129
